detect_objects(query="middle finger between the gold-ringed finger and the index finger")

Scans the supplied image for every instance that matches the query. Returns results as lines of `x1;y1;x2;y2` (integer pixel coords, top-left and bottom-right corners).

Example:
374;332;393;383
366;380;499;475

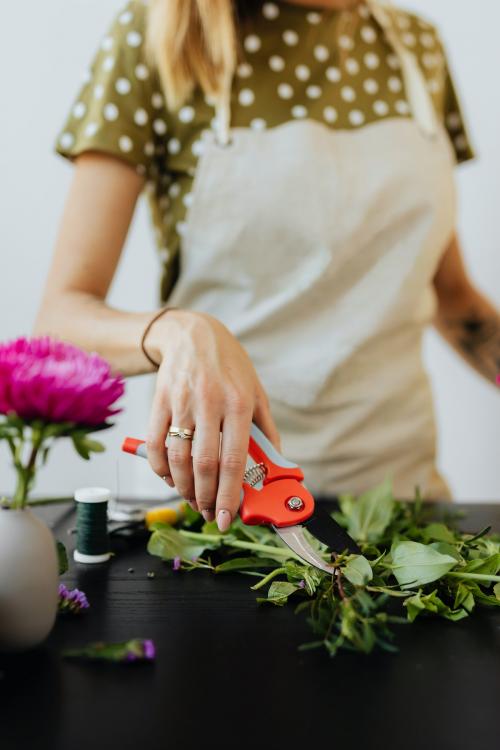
193;414;220;521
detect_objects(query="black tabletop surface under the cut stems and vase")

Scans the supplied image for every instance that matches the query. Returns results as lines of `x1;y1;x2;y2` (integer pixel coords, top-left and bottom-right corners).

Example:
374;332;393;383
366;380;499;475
0;504;500;750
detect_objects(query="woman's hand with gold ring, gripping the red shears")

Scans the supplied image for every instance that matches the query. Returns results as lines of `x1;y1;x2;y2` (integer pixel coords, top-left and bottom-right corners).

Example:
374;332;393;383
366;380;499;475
147;310;279;531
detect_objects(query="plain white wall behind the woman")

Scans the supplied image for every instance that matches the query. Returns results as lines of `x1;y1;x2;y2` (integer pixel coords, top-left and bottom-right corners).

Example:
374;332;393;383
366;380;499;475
0;0;500;501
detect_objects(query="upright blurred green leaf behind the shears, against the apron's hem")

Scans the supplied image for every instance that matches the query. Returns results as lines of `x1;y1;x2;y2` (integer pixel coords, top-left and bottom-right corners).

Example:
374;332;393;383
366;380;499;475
339;479;394;542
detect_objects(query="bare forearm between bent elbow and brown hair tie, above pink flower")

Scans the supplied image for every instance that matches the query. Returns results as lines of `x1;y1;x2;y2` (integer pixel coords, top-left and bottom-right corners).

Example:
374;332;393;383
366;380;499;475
34;291;154;375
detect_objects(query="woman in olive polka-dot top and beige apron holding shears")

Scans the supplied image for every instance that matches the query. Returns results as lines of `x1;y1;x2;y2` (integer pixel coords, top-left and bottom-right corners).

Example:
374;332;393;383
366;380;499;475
36;0;500;530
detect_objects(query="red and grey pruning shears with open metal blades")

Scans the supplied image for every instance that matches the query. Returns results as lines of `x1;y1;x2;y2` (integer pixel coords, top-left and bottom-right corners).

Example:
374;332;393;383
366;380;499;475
122;424;360;574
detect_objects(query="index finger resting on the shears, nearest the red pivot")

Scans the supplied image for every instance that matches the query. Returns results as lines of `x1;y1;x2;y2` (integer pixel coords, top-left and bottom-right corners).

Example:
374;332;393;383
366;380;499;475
215;410;251;531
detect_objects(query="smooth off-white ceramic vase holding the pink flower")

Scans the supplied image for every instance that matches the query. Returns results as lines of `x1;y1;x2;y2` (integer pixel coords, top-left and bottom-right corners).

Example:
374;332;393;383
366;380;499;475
0;508;59;651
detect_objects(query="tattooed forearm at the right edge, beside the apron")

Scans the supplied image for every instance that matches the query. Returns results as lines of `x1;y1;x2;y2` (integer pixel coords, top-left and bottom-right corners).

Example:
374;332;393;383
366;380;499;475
436;287;500;383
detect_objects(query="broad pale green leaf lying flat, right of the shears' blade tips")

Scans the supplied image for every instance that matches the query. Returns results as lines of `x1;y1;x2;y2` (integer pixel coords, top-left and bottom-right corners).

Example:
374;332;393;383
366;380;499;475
391;542;457;588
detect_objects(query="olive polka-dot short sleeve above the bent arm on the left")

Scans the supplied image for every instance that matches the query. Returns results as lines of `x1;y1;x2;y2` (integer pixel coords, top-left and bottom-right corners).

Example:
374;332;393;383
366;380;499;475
56;1;159;175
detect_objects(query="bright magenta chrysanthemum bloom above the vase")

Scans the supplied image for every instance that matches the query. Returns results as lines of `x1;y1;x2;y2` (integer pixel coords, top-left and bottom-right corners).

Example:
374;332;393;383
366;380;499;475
0;336;125;425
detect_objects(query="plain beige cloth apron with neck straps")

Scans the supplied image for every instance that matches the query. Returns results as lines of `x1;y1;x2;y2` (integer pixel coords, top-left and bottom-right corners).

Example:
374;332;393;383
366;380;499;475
169;2;455;506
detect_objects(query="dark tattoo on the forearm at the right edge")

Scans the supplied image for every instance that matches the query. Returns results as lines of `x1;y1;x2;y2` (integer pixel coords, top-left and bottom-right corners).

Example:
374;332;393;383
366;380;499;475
439;309;500;383
